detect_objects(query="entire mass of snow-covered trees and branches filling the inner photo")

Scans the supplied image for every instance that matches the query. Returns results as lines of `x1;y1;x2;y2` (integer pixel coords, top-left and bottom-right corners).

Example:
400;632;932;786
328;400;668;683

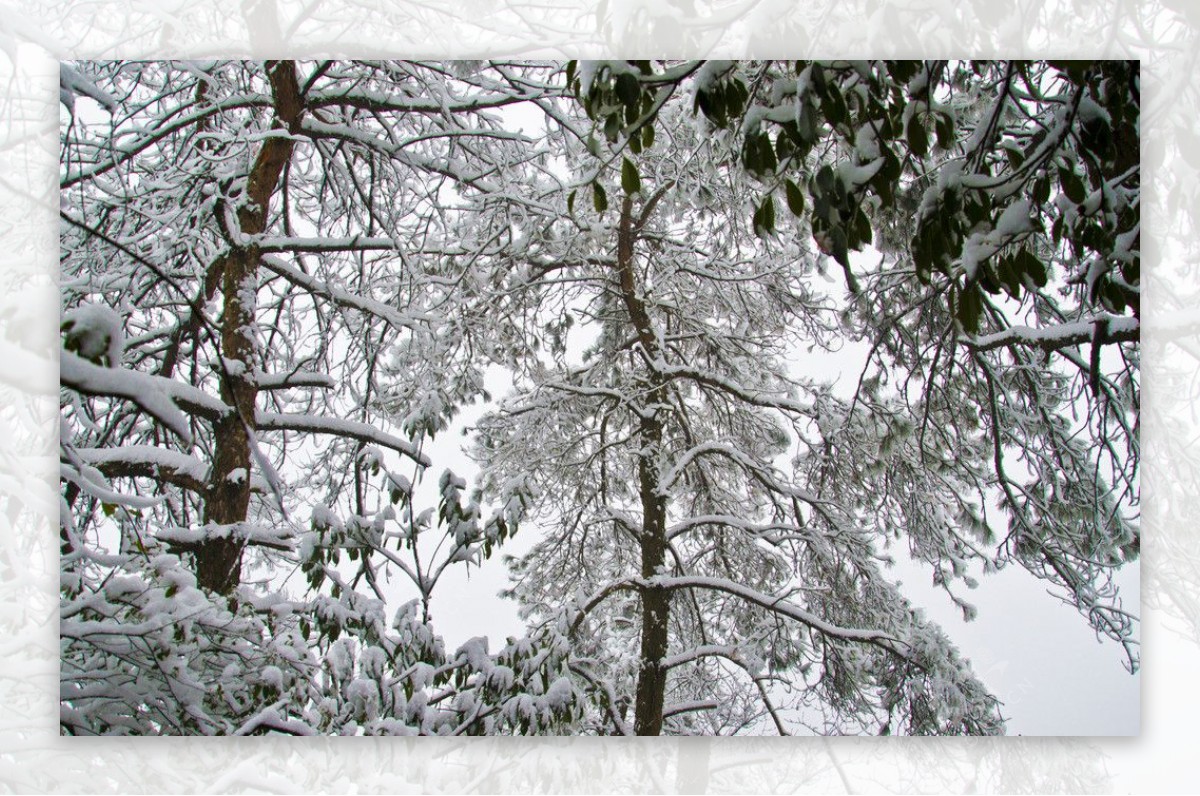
60;61;1140;735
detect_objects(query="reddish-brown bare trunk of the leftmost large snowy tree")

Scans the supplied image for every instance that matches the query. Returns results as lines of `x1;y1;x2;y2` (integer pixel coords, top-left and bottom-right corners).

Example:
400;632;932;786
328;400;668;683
196;61;302;594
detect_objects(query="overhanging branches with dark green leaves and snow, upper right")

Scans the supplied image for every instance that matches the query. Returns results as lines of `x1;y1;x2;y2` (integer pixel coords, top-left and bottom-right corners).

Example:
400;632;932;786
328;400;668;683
556;61;1141;666
